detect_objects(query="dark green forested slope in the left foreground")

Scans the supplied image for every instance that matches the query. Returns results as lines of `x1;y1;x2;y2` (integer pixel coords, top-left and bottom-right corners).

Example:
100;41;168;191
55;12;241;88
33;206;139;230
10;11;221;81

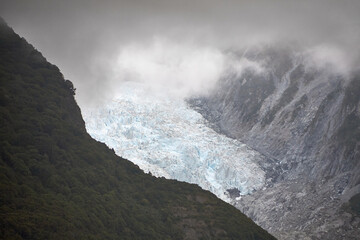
0;17;274;239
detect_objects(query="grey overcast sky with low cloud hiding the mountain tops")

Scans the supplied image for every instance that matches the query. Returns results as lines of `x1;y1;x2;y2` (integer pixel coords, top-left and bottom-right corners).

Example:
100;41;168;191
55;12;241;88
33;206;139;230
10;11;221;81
0;0;360;105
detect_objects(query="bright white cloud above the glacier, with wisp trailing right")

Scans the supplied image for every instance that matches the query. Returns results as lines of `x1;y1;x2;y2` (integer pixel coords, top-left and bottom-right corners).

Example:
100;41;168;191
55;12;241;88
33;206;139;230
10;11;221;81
95;37;264;101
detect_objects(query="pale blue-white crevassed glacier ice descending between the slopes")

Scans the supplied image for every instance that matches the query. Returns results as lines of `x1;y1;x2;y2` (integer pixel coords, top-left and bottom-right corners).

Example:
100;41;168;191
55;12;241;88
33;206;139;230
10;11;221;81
83;82;265;201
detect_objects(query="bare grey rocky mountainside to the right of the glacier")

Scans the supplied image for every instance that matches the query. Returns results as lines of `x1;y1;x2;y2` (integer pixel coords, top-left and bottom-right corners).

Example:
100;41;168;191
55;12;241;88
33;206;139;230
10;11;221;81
189;47;360;239
